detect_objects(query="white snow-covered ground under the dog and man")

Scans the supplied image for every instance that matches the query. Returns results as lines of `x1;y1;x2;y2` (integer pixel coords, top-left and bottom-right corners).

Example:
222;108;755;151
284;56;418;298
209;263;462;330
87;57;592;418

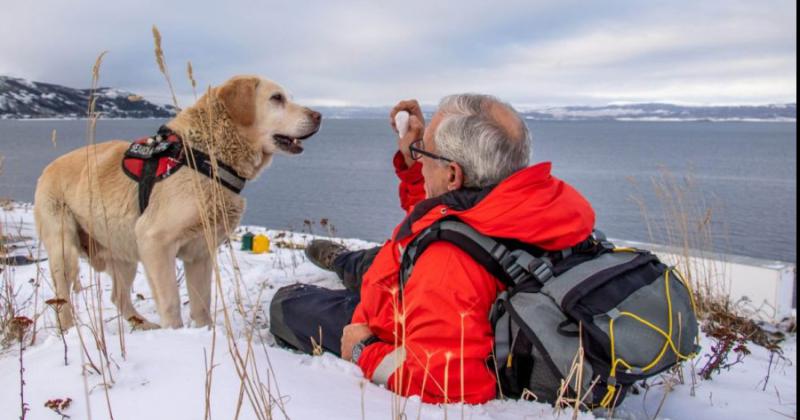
0;204;797;420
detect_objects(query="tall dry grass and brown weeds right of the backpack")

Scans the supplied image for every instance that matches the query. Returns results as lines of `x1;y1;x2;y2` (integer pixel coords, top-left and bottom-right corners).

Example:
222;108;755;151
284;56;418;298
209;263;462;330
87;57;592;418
629;168;784;416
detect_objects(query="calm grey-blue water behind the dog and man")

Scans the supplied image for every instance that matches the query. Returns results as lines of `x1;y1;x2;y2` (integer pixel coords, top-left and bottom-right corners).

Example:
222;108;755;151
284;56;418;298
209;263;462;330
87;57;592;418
0;119;797;262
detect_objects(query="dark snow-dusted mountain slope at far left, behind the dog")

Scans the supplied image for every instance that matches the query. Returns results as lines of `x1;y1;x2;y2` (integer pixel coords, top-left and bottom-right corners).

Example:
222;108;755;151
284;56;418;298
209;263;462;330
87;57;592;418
0;76;175;119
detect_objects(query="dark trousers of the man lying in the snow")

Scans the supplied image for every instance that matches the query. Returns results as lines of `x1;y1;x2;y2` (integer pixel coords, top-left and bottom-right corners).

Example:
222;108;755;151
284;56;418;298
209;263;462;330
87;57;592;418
269;247;380;356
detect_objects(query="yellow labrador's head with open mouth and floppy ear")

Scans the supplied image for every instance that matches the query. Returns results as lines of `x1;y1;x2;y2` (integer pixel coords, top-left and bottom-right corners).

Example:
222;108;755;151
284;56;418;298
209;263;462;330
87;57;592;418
216;76;322;155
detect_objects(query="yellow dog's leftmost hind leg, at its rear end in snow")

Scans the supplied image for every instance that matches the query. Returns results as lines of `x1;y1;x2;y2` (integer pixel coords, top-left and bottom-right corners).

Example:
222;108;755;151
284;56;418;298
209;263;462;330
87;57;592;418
34;200;80;330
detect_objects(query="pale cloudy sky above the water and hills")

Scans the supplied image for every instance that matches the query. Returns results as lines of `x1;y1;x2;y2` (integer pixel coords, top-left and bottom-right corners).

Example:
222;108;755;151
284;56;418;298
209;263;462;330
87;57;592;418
0;0;797;107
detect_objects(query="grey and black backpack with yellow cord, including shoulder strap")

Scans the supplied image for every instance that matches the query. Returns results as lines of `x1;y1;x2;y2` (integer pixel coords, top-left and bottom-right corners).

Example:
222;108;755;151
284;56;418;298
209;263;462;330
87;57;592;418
400;219;699;407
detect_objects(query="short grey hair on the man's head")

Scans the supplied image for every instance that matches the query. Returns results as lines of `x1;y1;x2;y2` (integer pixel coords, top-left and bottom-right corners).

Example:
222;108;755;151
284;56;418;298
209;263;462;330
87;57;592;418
434;94;531;188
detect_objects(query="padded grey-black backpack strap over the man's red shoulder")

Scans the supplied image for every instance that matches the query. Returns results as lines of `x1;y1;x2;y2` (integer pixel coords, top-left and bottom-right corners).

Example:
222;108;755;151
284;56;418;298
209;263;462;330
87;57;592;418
400;219;553;296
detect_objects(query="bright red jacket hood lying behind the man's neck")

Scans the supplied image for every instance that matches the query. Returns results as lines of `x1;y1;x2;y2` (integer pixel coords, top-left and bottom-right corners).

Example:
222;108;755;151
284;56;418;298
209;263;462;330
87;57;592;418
394;162;595;250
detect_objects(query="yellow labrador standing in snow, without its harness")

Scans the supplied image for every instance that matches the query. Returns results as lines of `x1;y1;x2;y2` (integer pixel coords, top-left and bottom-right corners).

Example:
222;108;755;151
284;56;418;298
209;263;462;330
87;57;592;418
35;76;321;329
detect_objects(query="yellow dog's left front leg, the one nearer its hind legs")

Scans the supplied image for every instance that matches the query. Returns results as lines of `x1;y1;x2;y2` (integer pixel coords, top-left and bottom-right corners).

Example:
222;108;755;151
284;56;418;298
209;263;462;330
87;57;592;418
136;231;183;328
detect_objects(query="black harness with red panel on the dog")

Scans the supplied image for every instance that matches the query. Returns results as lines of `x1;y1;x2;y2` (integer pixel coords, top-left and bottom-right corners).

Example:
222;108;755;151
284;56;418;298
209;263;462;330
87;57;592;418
122;126;246;213
